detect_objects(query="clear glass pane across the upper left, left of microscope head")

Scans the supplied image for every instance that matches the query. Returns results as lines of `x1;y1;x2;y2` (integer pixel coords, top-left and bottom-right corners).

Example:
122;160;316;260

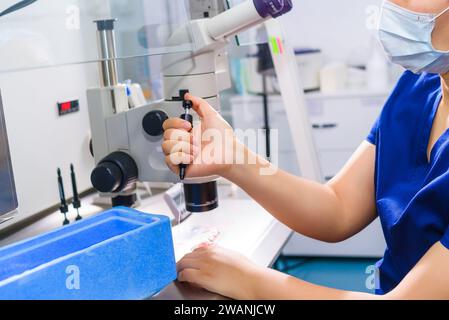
0;0;192;73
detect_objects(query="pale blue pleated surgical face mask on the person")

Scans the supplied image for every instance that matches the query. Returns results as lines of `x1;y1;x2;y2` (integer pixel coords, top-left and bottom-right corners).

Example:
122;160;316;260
379;0;449;74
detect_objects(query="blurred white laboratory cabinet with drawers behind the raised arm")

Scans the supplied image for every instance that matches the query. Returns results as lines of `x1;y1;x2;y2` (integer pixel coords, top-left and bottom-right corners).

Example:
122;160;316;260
230;90;388;257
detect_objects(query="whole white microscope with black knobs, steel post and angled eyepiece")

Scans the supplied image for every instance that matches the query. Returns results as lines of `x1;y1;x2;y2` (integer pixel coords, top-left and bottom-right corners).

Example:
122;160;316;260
87;0;292;213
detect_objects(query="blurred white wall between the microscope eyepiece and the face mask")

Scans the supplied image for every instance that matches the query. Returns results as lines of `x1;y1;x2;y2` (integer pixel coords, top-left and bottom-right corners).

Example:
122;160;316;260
281;0;382;64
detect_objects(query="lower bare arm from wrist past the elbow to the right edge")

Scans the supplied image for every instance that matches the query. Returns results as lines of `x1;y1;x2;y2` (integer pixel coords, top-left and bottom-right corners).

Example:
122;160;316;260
242;242;449;300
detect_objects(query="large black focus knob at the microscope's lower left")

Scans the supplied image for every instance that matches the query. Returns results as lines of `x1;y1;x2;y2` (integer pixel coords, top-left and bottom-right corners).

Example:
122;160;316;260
90;152;138;193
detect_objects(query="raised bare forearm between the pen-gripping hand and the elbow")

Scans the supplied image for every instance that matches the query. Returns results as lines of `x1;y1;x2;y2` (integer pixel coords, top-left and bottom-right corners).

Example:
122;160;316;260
225;149;347;242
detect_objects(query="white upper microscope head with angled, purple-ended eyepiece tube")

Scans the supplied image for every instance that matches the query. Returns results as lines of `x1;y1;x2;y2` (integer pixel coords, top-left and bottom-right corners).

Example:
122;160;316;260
162;0;292;105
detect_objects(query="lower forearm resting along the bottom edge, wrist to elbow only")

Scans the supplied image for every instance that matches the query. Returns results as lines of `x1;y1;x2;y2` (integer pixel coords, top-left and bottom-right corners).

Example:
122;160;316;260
242;268;383;300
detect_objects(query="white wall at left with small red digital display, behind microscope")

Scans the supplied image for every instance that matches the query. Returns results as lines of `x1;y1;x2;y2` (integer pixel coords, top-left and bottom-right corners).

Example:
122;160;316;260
0;0;109;228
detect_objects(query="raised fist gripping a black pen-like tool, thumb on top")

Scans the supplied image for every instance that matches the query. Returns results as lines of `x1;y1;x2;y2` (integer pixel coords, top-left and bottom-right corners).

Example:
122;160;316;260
162;94;241;178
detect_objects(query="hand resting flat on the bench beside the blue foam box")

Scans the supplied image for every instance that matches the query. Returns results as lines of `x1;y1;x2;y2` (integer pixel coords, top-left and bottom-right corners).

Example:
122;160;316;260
178;246;262;300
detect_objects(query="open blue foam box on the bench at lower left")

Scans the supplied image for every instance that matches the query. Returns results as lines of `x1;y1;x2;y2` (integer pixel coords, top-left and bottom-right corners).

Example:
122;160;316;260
0;207;176;300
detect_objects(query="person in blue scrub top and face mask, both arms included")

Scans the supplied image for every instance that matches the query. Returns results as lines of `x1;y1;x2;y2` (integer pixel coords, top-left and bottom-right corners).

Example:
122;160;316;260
163;0;449;299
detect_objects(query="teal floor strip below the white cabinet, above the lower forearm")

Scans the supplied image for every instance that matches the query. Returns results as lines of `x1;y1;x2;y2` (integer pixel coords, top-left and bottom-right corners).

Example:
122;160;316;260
275;256;377;293
